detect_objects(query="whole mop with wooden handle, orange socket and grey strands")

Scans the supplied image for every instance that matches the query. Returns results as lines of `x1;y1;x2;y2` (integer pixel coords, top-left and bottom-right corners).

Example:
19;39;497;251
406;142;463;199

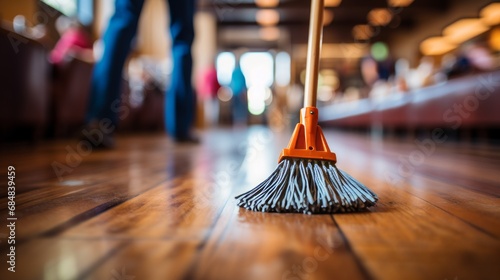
236;0;378;214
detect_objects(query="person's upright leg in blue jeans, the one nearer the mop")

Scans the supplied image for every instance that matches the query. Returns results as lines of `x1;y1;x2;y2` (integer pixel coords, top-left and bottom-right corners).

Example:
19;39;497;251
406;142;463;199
165;0;196;141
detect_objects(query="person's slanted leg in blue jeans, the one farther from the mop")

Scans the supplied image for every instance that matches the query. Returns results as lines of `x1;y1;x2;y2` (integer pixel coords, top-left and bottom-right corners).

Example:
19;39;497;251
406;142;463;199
86;0;144;125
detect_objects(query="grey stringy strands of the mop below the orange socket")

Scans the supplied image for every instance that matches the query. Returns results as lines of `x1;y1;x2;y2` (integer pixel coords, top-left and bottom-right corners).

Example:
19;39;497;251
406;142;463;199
236;158;378;214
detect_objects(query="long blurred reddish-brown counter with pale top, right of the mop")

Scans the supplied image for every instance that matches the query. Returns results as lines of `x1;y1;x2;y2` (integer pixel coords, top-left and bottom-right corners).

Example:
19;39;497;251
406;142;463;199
320;71;500;130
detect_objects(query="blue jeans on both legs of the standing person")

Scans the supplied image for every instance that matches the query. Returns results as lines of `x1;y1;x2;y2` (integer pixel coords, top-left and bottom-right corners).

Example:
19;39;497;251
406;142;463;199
86;0;195;138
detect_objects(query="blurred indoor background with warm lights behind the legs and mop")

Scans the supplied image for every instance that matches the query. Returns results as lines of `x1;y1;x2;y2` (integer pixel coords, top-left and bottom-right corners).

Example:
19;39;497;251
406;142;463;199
0;0;500;141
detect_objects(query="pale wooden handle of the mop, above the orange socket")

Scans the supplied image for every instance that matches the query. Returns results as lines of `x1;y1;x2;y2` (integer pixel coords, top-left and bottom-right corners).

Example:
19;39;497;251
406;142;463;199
304;0;325;107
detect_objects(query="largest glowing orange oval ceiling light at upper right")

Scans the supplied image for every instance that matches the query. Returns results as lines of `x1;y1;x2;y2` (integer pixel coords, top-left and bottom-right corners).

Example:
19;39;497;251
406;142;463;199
443;18;489;44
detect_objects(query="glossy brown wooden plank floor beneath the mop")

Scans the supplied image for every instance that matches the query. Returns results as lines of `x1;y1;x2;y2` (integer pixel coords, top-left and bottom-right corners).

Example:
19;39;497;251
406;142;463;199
0;127;500;280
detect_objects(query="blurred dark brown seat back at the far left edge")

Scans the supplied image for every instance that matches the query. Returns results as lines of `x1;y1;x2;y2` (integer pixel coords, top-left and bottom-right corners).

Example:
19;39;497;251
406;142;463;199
0;28;51;140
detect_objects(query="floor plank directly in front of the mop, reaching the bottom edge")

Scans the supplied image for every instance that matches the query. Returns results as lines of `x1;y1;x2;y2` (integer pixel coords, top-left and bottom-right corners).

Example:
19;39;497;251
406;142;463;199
186;202;367;279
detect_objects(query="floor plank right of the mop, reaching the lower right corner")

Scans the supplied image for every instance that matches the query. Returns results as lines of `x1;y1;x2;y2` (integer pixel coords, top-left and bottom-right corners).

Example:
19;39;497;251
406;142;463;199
334;174;500;279
